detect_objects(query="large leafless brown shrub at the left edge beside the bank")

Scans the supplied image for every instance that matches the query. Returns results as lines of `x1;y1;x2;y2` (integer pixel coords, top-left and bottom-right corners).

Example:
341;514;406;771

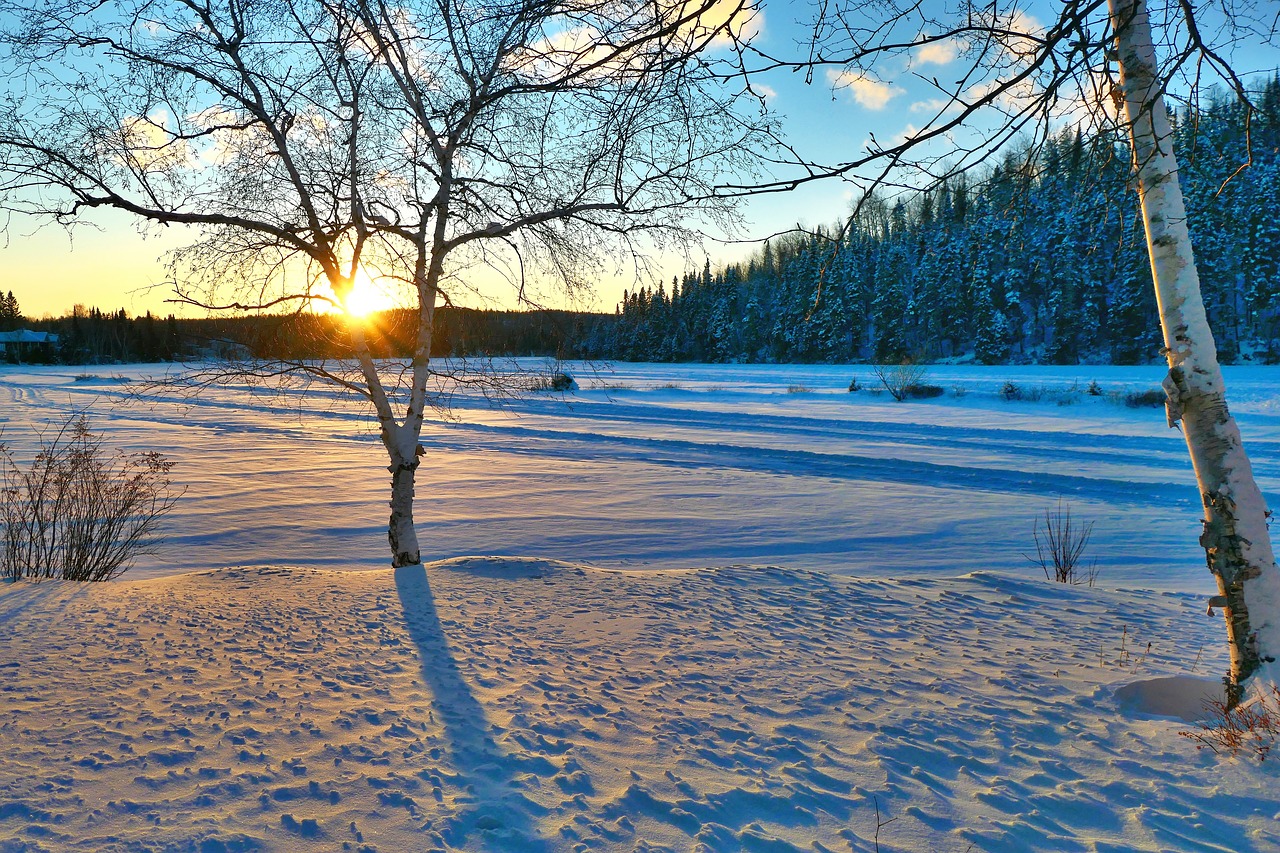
0;415;177;580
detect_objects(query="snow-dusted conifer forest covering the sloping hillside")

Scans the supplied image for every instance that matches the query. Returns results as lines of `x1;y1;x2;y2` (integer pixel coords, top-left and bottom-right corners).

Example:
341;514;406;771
588;78;1280;364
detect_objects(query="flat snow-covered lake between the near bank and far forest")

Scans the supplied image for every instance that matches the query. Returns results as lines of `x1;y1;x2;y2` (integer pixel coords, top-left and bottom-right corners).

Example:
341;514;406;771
0;360;1280;592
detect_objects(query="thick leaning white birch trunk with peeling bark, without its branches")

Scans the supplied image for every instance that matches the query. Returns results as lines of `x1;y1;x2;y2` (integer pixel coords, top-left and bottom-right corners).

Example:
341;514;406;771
1108;0;1280;704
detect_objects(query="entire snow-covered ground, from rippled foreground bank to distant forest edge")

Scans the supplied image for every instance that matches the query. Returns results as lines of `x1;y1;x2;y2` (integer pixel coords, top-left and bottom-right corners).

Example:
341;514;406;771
0;365;1280;852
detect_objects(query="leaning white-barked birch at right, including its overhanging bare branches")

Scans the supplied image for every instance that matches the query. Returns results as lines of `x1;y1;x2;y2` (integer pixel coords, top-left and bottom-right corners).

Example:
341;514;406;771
742;0;1280;703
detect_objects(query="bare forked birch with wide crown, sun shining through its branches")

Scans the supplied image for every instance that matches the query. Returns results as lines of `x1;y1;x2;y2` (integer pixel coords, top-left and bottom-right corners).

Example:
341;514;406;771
0;0;771;566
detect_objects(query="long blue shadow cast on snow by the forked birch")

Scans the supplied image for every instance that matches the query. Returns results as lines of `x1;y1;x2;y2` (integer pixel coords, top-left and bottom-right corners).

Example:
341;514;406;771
396;566;550;853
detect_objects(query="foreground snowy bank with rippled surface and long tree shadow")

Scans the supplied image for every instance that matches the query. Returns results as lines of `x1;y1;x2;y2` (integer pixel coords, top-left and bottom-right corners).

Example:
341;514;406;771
0;557;1280;853
